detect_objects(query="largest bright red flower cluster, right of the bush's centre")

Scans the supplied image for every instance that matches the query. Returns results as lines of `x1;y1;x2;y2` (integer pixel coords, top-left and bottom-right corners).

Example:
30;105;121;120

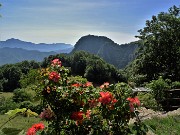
99;91;117;105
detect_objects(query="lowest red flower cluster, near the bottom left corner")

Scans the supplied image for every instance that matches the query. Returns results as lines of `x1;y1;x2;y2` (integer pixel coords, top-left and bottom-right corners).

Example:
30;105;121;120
26;123;44;135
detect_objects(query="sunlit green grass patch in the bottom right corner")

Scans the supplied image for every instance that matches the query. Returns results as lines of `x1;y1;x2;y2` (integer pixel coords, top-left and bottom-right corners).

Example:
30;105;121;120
144;114;180;135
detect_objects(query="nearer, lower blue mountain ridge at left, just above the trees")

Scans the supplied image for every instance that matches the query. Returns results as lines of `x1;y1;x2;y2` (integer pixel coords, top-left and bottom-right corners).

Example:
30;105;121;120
0;47;56;65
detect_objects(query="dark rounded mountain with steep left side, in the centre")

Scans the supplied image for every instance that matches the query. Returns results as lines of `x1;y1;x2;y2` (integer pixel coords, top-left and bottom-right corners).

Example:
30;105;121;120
72;35;138;68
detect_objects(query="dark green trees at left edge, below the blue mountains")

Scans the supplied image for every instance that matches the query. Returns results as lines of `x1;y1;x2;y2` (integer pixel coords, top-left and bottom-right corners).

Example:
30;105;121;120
0;61;39;92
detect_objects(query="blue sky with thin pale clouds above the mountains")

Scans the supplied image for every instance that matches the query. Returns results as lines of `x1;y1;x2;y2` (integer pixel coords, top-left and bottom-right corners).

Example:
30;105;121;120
0;0;180;45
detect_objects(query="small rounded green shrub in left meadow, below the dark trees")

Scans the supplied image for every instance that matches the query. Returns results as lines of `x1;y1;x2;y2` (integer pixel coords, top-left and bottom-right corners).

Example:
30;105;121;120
12;89;32;103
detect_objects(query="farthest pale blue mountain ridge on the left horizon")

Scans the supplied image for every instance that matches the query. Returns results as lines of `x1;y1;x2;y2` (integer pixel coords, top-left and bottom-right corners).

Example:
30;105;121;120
0;38;73;53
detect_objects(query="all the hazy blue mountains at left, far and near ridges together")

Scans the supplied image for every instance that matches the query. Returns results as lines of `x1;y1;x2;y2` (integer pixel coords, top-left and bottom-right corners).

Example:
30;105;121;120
0;38;73;65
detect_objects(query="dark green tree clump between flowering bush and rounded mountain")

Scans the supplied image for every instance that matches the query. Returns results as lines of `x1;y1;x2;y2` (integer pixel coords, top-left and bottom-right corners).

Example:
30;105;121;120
42;51;126;84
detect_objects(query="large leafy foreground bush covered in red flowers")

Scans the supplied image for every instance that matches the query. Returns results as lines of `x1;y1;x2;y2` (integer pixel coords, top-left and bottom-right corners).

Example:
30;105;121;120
32;59;147;135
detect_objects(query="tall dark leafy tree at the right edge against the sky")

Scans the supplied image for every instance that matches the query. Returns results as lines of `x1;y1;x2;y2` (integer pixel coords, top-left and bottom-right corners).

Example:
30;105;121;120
131;6;180;81
